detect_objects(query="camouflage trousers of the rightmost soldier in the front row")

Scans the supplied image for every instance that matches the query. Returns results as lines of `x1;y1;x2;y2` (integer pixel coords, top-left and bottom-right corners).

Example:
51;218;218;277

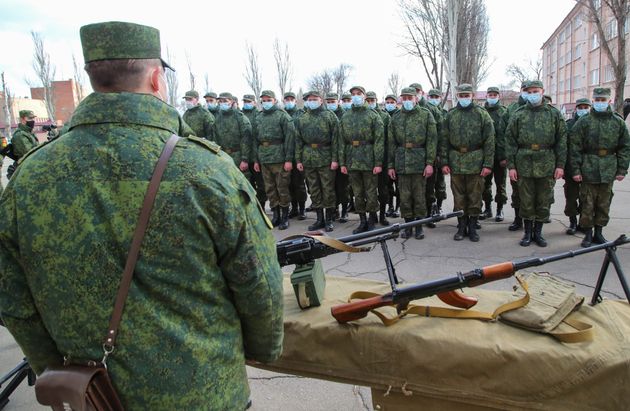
580;183;613;228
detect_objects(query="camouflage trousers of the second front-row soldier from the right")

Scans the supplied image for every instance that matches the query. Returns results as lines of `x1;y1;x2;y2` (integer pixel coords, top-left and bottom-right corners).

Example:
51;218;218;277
518;177;556;222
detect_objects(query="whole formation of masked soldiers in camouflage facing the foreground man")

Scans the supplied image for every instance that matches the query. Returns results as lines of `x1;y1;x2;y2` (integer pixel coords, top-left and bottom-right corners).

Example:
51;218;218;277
175;80;630;247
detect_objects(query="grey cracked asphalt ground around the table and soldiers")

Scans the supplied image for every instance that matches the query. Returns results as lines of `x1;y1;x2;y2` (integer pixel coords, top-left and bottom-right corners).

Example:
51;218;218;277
0;163;630;410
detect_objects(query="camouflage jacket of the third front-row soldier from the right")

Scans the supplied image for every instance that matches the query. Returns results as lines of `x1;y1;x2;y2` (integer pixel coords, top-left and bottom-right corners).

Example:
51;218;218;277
440;103;494;174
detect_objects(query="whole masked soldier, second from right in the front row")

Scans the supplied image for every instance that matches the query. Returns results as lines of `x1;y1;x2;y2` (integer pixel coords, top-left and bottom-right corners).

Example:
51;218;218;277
505;80;567;247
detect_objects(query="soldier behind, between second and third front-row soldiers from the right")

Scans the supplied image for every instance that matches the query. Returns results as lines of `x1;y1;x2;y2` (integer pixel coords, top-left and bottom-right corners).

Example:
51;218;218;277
479;87;507;222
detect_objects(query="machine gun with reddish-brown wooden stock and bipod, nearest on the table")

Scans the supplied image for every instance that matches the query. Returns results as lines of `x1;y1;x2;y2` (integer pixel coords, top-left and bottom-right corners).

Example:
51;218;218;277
331;235;630;324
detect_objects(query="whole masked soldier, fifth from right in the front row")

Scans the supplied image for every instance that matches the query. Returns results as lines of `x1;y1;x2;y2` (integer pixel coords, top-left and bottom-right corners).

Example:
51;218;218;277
339;86;385;234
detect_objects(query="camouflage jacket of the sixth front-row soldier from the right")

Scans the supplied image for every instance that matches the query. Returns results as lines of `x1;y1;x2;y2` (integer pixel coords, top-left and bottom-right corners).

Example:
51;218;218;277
295;107;339;168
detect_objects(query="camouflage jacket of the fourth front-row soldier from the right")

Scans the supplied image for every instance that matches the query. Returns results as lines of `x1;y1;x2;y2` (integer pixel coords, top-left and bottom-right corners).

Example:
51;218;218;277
387;106;437;174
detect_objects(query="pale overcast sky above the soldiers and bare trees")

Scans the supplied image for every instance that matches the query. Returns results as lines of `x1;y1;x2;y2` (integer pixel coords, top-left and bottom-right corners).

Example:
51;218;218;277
0;0;575;99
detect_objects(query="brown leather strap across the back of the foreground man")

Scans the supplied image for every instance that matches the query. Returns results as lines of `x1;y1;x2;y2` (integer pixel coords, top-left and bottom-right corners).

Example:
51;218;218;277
103;134;180;350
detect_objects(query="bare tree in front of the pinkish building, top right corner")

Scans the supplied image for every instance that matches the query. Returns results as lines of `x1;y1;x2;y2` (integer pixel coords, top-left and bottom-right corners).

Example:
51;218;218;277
577;0;630;114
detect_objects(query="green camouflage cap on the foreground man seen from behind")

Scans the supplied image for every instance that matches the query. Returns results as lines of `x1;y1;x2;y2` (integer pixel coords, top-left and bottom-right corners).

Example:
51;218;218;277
79;21;173;70
